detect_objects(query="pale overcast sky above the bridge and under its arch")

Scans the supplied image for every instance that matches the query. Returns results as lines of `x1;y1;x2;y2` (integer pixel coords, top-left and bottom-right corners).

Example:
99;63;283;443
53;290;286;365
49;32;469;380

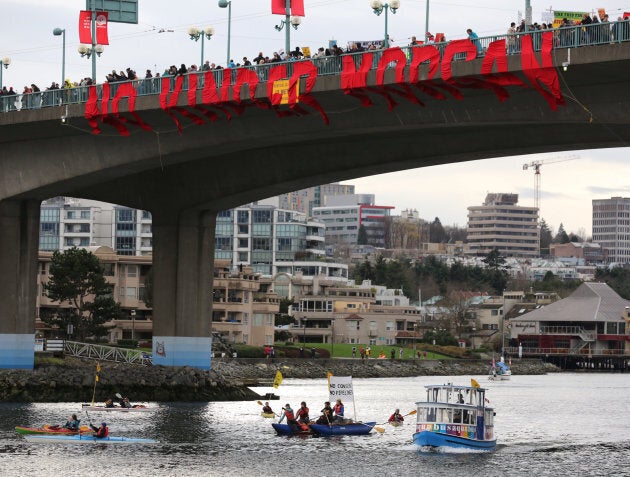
0;0;630;236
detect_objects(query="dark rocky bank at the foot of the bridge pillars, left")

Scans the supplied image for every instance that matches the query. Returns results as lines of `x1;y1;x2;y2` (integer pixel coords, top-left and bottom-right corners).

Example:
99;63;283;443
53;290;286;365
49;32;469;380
0;358;258;404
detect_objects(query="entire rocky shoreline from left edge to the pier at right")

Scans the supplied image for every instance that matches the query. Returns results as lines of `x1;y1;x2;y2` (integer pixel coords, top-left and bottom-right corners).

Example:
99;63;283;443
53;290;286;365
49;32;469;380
0;357;560;403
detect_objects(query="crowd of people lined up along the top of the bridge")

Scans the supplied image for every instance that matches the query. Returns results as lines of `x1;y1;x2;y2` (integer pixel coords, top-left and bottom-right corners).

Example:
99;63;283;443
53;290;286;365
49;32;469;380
0;13;630;112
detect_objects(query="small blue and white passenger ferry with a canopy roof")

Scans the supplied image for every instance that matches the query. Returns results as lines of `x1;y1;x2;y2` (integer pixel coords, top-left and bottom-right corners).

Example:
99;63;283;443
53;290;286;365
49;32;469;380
413;379;497;450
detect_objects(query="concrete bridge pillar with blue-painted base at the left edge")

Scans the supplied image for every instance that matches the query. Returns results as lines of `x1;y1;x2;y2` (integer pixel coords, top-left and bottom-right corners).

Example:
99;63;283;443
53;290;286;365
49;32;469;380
0;200;40;369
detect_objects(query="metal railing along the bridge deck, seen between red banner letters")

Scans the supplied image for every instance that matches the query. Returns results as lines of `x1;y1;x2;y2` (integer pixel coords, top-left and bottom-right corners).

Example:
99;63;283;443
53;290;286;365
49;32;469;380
0;20;630;112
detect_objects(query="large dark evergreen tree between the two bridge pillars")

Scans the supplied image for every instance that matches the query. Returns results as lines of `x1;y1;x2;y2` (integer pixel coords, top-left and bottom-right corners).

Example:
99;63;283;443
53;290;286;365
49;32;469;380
42;247;121;341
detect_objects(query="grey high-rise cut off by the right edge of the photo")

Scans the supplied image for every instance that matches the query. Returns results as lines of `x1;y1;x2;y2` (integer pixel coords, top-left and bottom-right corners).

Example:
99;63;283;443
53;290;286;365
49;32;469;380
593;197;630;264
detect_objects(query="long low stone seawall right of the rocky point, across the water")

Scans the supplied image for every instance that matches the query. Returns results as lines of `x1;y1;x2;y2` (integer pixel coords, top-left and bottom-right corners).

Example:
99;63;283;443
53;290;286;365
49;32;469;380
212;358;560;385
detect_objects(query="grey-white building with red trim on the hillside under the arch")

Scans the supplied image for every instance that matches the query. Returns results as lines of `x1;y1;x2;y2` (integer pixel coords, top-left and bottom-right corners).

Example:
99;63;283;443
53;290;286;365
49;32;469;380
313;194;394;248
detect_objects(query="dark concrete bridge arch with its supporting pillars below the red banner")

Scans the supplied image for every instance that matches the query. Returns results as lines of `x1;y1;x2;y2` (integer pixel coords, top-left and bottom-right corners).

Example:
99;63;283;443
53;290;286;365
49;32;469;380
0;45;630;367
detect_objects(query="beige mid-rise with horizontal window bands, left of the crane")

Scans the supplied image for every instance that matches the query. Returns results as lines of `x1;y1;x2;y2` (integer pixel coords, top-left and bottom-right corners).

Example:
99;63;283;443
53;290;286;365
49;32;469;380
465;193;540;257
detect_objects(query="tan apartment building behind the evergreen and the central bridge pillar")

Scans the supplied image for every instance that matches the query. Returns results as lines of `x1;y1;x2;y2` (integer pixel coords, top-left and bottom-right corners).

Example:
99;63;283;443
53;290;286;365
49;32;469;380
36;246;280;346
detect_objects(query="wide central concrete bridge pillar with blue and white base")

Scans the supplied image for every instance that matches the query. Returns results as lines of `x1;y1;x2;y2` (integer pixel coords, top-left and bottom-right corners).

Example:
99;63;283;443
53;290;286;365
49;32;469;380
153;210;216;369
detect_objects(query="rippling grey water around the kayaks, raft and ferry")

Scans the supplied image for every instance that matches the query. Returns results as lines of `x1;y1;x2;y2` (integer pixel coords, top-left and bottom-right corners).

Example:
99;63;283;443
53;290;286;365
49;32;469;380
0;373;630;477
